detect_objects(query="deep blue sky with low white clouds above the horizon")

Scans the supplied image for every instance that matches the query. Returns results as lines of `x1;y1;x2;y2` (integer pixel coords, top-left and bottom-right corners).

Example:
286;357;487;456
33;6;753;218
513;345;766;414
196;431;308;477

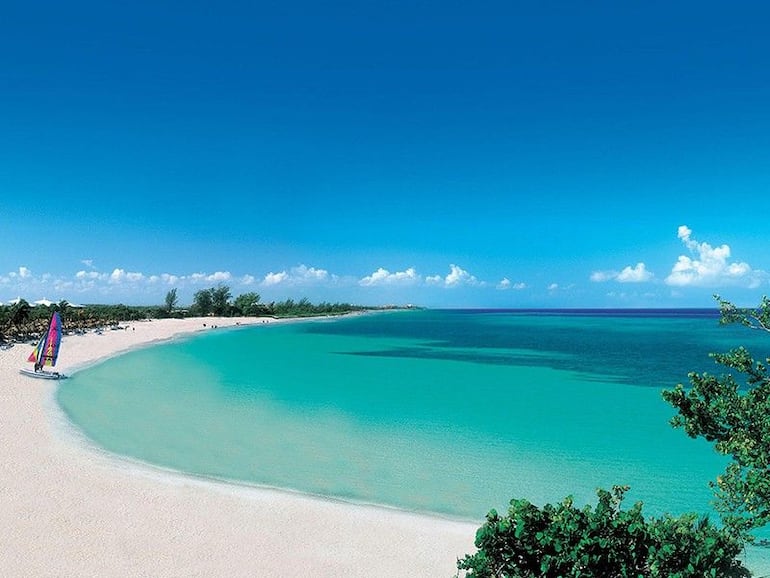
0;0;770;307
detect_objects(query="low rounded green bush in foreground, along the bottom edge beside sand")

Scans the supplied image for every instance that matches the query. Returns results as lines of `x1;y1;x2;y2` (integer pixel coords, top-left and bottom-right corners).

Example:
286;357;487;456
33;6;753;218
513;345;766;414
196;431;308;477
457;486;749;578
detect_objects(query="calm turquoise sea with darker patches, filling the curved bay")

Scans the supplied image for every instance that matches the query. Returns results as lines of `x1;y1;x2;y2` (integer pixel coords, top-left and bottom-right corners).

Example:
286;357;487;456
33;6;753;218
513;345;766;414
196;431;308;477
58;310;770;564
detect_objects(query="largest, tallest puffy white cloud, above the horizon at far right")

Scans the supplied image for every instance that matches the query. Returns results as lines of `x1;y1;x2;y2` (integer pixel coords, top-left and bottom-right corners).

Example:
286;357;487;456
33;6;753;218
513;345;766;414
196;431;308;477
666;225;767;289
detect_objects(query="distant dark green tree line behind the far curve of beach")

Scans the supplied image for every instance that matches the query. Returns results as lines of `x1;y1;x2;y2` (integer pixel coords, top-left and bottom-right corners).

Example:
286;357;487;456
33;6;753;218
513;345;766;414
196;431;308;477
0;285;372;343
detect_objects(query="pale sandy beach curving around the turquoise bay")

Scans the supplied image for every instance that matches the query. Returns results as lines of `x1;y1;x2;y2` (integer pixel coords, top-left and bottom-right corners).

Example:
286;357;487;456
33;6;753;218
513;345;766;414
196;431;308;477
0;319;477;578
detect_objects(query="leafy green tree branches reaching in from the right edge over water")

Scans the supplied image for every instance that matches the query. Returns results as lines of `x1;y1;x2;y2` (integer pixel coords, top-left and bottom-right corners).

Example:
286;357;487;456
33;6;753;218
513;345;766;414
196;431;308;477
663;295;770;541
